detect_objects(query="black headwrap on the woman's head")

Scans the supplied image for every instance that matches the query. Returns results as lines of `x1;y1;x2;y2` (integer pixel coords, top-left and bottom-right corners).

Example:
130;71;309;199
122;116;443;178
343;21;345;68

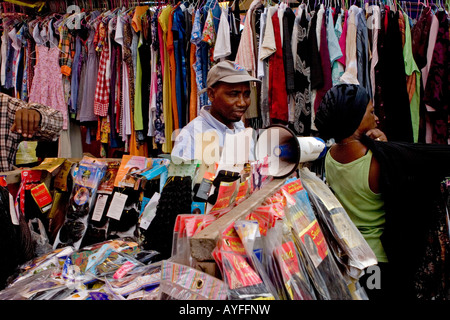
314;84;370;141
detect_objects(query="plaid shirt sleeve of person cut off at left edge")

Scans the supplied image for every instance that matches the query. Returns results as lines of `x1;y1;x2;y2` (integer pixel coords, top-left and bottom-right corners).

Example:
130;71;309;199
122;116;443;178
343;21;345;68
0;93;63;172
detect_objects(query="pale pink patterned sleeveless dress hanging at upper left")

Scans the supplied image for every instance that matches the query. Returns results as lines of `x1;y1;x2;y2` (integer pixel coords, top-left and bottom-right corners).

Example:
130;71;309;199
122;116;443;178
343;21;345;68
29;45;68;130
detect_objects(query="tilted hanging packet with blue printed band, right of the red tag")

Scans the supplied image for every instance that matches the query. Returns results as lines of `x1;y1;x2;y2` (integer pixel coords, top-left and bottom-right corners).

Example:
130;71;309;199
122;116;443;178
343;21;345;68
53;157;106;249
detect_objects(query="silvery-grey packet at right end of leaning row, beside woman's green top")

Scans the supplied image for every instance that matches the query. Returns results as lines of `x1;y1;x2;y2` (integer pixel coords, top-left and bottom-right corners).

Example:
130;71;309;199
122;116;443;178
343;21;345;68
300;168;377;279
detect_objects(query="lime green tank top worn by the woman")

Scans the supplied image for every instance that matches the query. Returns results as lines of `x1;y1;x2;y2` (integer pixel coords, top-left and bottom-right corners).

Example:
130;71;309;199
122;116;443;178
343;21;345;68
325;150;388;262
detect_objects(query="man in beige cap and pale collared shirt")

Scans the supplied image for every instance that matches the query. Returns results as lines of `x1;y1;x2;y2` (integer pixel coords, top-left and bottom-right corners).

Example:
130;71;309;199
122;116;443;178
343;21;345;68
172;60;260;160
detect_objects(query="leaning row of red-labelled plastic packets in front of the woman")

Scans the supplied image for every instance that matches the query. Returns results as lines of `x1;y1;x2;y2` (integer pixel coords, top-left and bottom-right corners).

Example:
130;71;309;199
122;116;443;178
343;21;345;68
212;175;377;300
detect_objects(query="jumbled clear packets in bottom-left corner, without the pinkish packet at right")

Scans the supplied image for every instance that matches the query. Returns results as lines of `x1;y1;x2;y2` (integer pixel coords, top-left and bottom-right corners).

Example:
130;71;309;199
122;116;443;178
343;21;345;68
0;239;161;300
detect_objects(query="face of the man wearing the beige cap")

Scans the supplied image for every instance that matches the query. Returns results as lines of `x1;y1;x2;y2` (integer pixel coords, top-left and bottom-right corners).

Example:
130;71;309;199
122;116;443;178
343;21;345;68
208;82;251;128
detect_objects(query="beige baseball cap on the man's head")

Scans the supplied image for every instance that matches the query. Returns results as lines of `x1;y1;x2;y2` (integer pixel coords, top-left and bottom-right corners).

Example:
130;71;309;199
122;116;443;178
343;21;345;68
199;60;261;94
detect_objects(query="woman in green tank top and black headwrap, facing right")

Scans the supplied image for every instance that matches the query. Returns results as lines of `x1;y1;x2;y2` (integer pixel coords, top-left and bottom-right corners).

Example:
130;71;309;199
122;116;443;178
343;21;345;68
315;84;450;299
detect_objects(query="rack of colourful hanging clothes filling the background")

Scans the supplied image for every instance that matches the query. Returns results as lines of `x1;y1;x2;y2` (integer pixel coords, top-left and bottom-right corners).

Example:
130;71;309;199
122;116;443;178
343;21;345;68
0;0;450;165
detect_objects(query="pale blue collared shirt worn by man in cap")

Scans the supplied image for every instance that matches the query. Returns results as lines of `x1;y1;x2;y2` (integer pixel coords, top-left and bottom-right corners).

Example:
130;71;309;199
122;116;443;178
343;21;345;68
172;106;245;159
